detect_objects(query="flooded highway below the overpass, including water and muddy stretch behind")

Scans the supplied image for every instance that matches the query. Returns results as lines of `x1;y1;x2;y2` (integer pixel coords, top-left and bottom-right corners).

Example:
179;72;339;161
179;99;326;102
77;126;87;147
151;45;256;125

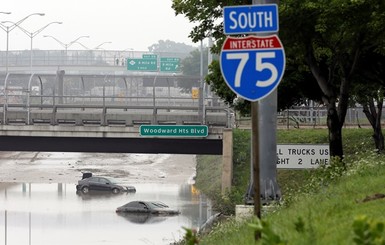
0;152;213;245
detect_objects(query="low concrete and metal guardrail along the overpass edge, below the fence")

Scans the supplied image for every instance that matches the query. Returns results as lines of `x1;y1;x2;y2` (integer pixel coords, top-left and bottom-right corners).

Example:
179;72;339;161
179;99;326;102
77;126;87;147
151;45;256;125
0;104;234;128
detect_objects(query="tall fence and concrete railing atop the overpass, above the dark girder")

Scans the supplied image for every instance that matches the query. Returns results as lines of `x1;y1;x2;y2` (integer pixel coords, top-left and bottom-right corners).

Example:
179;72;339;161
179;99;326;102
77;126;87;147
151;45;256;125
0;70;234;128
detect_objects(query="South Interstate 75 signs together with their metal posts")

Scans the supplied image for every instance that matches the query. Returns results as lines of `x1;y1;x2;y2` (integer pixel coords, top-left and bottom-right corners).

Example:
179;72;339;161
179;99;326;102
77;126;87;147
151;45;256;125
220;0;285;237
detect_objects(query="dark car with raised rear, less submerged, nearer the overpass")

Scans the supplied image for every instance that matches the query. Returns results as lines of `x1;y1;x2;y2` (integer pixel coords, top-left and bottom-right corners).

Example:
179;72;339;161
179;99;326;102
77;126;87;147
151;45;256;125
76;175;136;194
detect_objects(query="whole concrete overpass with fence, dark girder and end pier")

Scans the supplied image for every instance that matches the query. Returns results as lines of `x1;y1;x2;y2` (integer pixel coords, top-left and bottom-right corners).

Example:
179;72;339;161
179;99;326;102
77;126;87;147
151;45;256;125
0;49;234;191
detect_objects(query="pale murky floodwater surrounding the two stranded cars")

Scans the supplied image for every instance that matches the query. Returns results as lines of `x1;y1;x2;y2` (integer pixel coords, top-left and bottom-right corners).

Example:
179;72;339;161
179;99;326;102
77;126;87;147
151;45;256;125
0;183;212;245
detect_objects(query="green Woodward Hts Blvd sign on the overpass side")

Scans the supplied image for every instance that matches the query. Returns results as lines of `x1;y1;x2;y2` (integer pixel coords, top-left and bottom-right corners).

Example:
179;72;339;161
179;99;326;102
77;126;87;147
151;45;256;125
139;125;208;137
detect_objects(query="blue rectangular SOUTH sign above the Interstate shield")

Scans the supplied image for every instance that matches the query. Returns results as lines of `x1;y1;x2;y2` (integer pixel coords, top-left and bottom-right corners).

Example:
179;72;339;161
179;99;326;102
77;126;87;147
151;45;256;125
223;4;278;35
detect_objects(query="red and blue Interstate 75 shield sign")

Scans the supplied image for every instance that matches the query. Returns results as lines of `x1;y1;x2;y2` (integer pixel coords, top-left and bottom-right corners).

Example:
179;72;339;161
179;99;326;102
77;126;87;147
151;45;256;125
220;35;285;101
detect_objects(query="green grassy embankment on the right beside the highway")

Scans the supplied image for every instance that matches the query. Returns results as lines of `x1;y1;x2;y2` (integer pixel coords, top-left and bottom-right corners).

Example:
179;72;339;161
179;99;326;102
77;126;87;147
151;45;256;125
189;129;385;245
